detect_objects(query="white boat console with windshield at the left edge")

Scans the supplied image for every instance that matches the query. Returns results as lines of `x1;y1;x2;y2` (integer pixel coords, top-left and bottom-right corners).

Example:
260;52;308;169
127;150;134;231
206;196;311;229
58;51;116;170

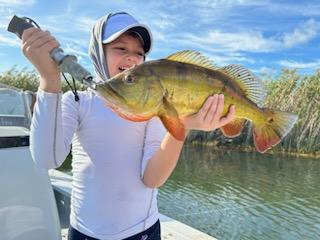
0;84;61;240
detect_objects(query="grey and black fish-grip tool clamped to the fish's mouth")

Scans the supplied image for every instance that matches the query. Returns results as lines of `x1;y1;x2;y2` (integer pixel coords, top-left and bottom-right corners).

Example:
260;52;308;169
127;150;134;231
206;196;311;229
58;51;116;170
7;15;96;89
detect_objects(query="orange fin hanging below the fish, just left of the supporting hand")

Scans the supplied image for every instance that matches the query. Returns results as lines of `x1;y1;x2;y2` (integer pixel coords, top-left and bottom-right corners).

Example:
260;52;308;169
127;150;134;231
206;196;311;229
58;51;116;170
159;98;185;141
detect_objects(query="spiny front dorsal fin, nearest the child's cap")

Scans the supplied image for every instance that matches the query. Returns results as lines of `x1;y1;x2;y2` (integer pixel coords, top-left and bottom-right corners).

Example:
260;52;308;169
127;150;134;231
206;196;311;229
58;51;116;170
166;50;218;70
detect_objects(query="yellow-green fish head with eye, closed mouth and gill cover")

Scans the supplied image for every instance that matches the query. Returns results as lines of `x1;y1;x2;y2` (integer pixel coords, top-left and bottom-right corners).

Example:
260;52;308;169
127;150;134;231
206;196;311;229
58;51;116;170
96;64;164;116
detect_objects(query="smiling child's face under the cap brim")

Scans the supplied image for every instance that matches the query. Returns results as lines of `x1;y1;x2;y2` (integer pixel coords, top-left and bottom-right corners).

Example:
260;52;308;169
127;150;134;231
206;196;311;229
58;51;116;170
103;33;144;78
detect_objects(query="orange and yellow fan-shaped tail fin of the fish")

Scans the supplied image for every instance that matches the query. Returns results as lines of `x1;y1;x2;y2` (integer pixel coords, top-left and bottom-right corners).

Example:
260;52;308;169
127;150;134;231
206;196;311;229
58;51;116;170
253;109;298;153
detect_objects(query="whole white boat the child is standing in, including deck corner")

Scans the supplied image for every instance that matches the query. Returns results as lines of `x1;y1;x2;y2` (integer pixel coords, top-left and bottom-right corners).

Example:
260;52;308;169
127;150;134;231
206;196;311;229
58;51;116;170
0;83;214;240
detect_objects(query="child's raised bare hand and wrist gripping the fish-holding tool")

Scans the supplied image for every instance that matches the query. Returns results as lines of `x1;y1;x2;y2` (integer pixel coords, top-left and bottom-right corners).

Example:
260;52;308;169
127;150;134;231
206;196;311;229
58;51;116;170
21;27;61;92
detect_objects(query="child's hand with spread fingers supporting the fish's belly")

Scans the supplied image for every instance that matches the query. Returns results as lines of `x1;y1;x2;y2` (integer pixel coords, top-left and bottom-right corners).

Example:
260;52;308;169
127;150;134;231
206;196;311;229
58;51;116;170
182;94;235;131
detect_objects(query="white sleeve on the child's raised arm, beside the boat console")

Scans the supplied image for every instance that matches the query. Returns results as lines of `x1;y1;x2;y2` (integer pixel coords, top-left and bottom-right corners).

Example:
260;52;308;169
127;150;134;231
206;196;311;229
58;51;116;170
30;89;78;169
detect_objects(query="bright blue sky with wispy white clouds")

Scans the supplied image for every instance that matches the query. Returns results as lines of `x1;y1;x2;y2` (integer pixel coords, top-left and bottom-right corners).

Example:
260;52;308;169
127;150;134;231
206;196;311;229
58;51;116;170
0;0;320;78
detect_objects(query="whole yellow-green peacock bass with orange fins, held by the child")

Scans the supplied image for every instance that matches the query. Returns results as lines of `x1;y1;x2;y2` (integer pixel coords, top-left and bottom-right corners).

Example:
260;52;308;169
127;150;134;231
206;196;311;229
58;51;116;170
96;50;297;153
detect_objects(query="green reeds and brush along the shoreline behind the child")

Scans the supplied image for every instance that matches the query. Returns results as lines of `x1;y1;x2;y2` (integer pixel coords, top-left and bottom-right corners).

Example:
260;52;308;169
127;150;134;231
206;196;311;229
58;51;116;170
0;68;320;155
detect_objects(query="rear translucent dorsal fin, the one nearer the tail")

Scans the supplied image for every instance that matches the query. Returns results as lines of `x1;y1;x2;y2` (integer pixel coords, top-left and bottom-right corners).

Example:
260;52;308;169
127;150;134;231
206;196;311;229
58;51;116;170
221;64;267;106
